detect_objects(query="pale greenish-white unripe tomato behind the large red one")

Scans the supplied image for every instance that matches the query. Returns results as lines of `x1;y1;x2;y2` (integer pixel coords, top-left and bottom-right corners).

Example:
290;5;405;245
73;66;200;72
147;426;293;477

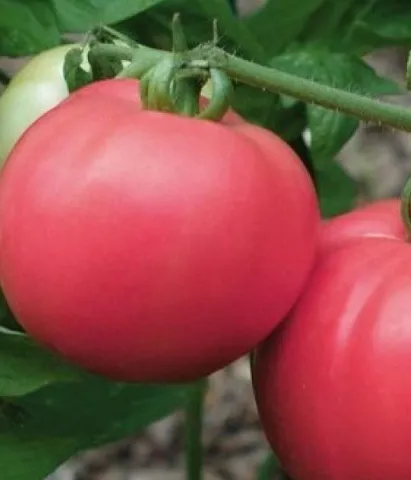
0;44;86;165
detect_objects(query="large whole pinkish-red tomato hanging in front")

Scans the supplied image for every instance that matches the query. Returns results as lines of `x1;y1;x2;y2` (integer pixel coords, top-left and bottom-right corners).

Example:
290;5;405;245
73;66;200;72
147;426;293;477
0;80;320;382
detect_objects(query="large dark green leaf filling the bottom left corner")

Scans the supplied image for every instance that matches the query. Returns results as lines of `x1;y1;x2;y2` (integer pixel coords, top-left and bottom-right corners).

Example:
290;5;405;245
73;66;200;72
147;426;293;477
0;376;202;480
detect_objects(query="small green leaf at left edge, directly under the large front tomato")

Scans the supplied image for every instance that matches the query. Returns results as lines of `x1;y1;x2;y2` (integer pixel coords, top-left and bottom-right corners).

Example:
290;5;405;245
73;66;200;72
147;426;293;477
0;327;82;396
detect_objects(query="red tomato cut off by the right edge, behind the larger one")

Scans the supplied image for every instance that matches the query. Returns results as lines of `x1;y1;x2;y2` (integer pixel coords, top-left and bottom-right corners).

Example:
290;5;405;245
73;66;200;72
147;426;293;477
253;200;411;480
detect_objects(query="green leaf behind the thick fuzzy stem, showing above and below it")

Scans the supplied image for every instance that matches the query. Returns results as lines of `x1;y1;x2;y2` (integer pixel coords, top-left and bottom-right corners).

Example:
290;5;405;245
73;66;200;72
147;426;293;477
271;46;402;164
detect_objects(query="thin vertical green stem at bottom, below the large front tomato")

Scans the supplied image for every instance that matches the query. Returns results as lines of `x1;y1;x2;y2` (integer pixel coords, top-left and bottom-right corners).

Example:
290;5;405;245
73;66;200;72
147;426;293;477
185;381;206;480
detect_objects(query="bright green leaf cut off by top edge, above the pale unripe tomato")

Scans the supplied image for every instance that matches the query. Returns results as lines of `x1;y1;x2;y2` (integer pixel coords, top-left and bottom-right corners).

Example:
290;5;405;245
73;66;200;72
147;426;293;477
49;0;164;32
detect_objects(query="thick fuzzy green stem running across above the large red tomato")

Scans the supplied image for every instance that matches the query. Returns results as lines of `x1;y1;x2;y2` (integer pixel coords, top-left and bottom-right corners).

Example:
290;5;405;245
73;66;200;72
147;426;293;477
94;38;411;132
